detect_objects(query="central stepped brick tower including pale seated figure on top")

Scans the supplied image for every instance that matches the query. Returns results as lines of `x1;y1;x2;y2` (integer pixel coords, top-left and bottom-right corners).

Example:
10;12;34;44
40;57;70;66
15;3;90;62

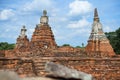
31;10;57;49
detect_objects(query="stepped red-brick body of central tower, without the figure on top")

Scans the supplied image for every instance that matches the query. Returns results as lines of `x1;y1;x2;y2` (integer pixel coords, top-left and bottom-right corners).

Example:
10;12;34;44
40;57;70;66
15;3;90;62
31;24;57;48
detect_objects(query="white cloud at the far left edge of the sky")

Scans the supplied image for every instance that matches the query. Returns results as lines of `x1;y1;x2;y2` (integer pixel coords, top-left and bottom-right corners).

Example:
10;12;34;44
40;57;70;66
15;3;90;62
0;9;15;20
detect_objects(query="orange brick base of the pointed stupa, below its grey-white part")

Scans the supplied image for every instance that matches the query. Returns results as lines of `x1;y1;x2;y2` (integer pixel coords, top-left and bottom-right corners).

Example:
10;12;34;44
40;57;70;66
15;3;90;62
86;40;115;56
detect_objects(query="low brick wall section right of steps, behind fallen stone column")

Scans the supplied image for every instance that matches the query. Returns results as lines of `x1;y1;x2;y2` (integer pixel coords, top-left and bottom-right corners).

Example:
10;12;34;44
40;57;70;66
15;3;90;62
55;57;120;80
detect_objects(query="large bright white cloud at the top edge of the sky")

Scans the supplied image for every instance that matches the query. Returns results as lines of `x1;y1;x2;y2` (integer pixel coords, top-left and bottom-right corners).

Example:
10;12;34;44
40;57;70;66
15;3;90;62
69;0;92;15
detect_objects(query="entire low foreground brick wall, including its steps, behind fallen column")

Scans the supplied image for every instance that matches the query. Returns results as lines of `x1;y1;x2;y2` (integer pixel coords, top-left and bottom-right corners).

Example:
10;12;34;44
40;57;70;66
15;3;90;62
0;57;120;80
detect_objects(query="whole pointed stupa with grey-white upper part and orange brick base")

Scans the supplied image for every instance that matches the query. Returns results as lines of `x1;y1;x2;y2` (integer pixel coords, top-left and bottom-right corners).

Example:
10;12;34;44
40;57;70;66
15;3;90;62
86;8;115;56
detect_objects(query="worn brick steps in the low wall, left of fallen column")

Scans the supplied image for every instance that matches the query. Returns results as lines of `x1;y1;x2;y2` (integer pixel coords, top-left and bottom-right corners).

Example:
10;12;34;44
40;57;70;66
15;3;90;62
33;57;51;76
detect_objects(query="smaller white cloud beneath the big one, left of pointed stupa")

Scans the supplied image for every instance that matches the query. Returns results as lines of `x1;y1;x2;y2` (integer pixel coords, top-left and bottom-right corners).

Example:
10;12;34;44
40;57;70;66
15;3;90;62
68;18;90;28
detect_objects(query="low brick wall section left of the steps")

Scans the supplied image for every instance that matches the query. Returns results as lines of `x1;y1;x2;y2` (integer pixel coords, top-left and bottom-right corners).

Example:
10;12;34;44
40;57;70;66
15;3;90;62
0;58;35;77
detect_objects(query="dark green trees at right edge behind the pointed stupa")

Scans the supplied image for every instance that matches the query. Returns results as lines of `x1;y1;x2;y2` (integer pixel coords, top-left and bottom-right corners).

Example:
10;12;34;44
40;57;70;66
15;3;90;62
105;28;120;54
